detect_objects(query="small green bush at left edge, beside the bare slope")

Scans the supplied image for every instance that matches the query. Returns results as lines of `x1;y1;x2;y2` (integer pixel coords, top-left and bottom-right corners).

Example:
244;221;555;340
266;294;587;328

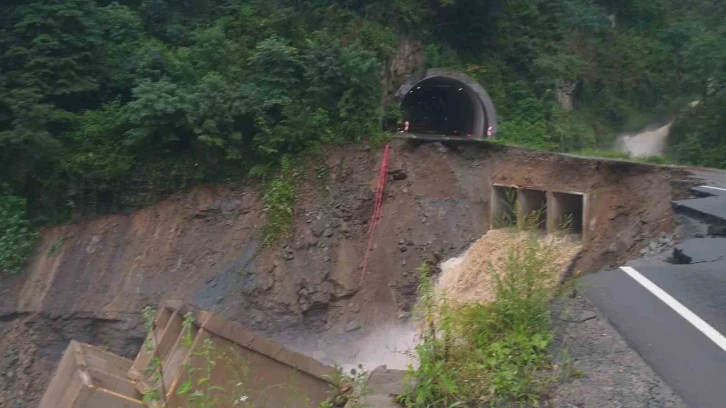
0;186;38;274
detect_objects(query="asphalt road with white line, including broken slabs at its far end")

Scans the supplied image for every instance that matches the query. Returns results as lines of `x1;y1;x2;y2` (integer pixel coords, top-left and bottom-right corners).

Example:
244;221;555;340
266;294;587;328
581;187;726;408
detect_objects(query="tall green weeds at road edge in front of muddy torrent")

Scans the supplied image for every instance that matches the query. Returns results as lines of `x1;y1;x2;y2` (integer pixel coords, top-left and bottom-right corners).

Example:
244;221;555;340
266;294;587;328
399;232;557;407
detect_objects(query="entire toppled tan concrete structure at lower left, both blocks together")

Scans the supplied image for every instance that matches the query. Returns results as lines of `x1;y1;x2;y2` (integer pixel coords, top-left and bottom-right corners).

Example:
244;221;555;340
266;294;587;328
39;304;335;408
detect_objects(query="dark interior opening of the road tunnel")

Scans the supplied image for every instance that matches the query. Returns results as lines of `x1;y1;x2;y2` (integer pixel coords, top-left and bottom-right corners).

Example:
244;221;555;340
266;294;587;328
401;77;475;136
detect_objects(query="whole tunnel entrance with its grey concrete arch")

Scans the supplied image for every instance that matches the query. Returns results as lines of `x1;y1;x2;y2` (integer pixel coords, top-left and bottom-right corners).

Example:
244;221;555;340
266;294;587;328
395;69;498;140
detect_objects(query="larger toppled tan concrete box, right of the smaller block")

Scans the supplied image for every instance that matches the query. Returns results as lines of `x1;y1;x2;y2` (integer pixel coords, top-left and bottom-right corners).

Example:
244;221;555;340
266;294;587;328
128;305;334;408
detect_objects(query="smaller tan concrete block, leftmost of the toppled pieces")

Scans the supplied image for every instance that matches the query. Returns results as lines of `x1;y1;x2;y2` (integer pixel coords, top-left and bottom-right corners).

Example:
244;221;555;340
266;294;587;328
39;341;145;408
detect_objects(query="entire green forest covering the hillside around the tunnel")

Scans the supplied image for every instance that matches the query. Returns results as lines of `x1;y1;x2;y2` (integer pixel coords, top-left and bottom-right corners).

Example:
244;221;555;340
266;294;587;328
0;0;726;272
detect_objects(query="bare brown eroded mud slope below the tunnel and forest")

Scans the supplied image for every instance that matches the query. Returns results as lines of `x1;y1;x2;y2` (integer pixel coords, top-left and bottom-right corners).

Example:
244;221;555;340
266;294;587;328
0;142;688;406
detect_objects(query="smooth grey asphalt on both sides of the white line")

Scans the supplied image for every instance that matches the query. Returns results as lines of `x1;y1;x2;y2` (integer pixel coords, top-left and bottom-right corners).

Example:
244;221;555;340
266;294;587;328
582;261;726;408
